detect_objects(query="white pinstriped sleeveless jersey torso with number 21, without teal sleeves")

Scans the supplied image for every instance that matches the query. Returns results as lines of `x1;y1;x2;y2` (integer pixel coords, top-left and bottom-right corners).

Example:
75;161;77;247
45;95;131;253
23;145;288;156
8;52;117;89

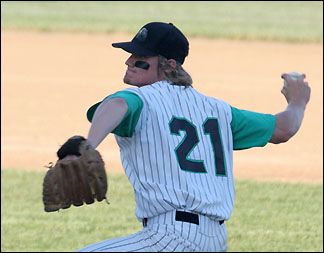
116;81;234;220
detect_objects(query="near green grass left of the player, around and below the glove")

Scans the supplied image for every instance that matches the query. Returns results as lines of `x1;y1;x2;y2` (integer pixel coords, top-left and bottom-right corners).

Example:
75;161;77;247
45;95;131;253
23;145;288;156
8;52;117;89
1;170;141;252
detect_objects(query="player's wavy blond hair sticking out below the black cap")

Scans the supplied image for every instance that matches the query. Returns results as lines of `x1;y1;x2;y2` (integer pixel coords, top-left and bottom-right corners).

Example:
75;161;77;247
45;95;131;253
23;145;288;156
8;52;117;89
158;55;192;88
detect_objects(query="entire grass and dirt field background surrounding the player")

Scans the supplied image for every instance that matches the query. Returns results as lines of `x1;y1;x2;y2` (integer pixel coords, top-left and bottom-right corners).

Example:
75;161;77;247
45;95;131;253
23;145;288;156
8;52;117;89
1;1;323;252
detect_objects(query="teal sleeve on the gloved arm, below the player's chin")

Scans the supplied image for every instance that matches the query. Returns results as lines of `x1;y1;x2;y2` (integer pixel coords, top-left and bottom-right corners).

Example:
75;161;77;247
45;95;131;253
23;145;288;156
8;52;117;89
87;91;143;137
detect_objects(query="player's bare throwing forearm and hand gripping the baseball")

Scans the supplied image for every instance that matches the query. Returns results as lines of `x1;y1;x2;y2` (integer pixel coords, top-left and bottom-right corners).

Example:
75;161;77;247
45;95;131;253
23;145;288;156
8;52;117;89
269;74;311;144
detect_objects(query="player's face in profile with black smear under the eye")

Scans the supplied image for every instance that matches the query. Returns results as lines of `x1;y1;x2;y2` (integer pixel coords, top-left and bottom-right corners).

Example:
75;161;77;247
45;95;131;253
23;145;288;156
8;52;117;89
124;54;161;87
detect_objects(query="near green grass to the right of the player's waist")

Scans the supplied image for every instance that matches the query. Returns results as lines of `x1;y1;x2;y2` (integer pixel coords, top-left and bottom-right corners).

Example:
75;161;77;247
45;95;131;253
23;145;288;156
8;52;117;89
227;181;323;252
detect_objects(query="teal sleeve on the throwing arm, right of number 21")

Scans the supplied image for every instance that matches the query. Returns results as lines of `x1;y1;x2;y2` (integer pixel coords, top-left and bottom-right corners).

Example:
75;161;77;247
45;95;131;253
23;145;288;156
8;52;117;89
231;107;276;150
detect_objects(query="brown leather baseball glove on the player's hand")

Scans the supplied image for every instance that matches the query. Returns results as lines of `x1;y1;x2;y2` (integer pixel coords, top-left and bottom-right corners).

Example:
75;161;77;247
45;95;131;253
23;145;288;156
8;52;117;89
43;136;108;212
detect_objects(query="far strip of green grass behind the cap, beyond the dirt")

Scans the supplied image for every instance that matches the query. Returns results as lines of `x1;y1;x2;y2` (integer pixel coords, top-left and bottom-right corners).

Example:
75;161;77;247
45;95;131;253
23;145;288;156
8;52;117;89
1;1;323;42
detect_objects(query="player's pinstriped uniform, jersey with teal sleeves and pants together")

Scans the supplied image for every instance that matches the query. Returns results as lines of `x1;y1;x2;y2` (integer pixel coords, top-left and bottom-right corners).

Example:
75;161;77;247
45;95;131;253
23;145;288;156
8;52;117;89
79;81;275;252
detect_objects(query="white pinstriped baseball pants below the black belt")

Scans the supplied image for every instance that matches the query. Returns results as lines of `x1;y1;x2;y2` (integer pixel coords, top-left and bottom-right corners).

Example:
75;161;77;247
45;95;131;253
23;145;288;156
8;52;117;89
77;210;227;252
